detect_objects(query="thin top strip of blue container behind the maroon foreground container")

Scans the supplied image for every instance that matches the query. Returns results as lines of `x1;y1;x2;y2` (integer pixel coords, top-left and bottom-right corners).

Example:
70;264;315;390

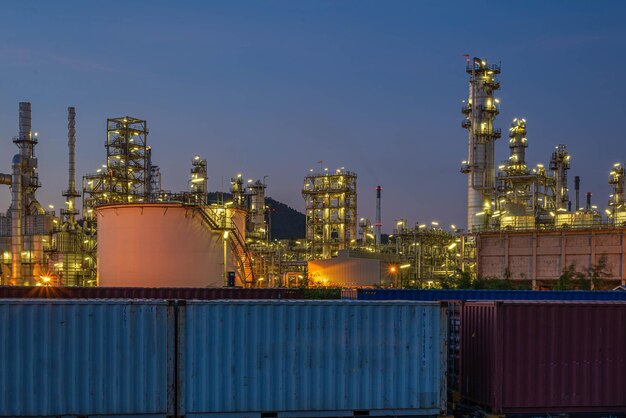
357;289;626;301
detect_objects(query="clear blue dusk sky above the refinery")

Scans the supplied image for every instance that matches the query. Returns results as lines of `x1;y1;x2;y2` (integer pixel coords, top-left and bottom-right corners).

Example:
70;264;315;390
0;0;626;232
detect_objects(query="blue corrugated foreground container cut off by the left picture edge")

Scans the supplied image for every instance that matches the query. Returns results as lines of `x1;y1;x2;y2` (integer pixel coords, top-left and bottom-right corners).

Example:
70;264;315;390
0;299;174;417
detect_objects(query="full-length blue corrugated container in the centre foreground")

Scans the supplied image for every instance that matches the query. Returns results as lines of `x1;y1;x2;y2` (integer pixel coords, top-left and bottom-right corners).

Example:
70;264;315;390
179;300;447;417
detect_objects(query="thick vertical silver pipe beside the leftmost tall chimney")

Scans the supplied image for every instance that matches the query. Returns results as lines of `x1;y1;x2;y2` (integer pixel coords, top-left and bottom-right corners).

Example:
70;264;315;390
11;154;23;284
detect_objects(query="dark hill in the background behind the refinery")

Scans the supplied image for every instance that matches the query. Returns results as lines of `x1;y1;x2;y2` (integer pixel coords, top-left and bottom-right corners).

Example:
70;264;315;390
209;192;306;240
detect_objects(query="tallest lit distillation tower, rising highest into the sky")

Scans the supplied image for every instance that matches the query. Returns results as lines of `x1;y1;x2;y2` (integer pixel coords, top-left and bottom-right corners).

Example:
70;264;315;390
461;57;501;231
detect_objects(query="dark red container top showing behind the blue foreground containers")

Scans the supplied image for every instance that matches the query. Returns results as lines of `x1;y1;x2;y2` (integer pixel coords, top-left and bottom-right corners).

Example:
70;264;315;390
0;286;304;300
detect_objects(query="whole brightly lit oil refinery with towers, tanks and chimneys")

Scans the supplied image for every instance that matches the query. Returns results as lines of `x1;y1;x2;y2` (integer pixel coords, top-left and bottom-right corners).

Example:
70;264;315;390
0;58;626;288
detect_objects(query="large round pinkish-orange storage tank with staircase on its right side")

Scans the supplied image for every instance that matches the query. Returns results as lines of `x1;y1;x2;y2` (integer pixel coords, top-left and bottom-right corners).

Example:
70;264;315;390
96;203;245;287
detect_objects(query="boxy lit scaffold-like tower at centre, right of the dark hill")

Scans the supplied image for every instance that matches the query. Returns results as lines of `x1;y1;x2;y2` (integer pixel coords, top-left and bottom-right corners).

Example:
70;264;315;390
302;168;357;259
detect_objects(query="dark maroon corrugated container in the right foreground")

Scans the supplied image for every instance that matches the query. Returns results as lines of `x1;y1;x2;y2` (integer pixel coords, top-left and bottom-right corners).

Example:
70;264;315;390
461;302;626;416
